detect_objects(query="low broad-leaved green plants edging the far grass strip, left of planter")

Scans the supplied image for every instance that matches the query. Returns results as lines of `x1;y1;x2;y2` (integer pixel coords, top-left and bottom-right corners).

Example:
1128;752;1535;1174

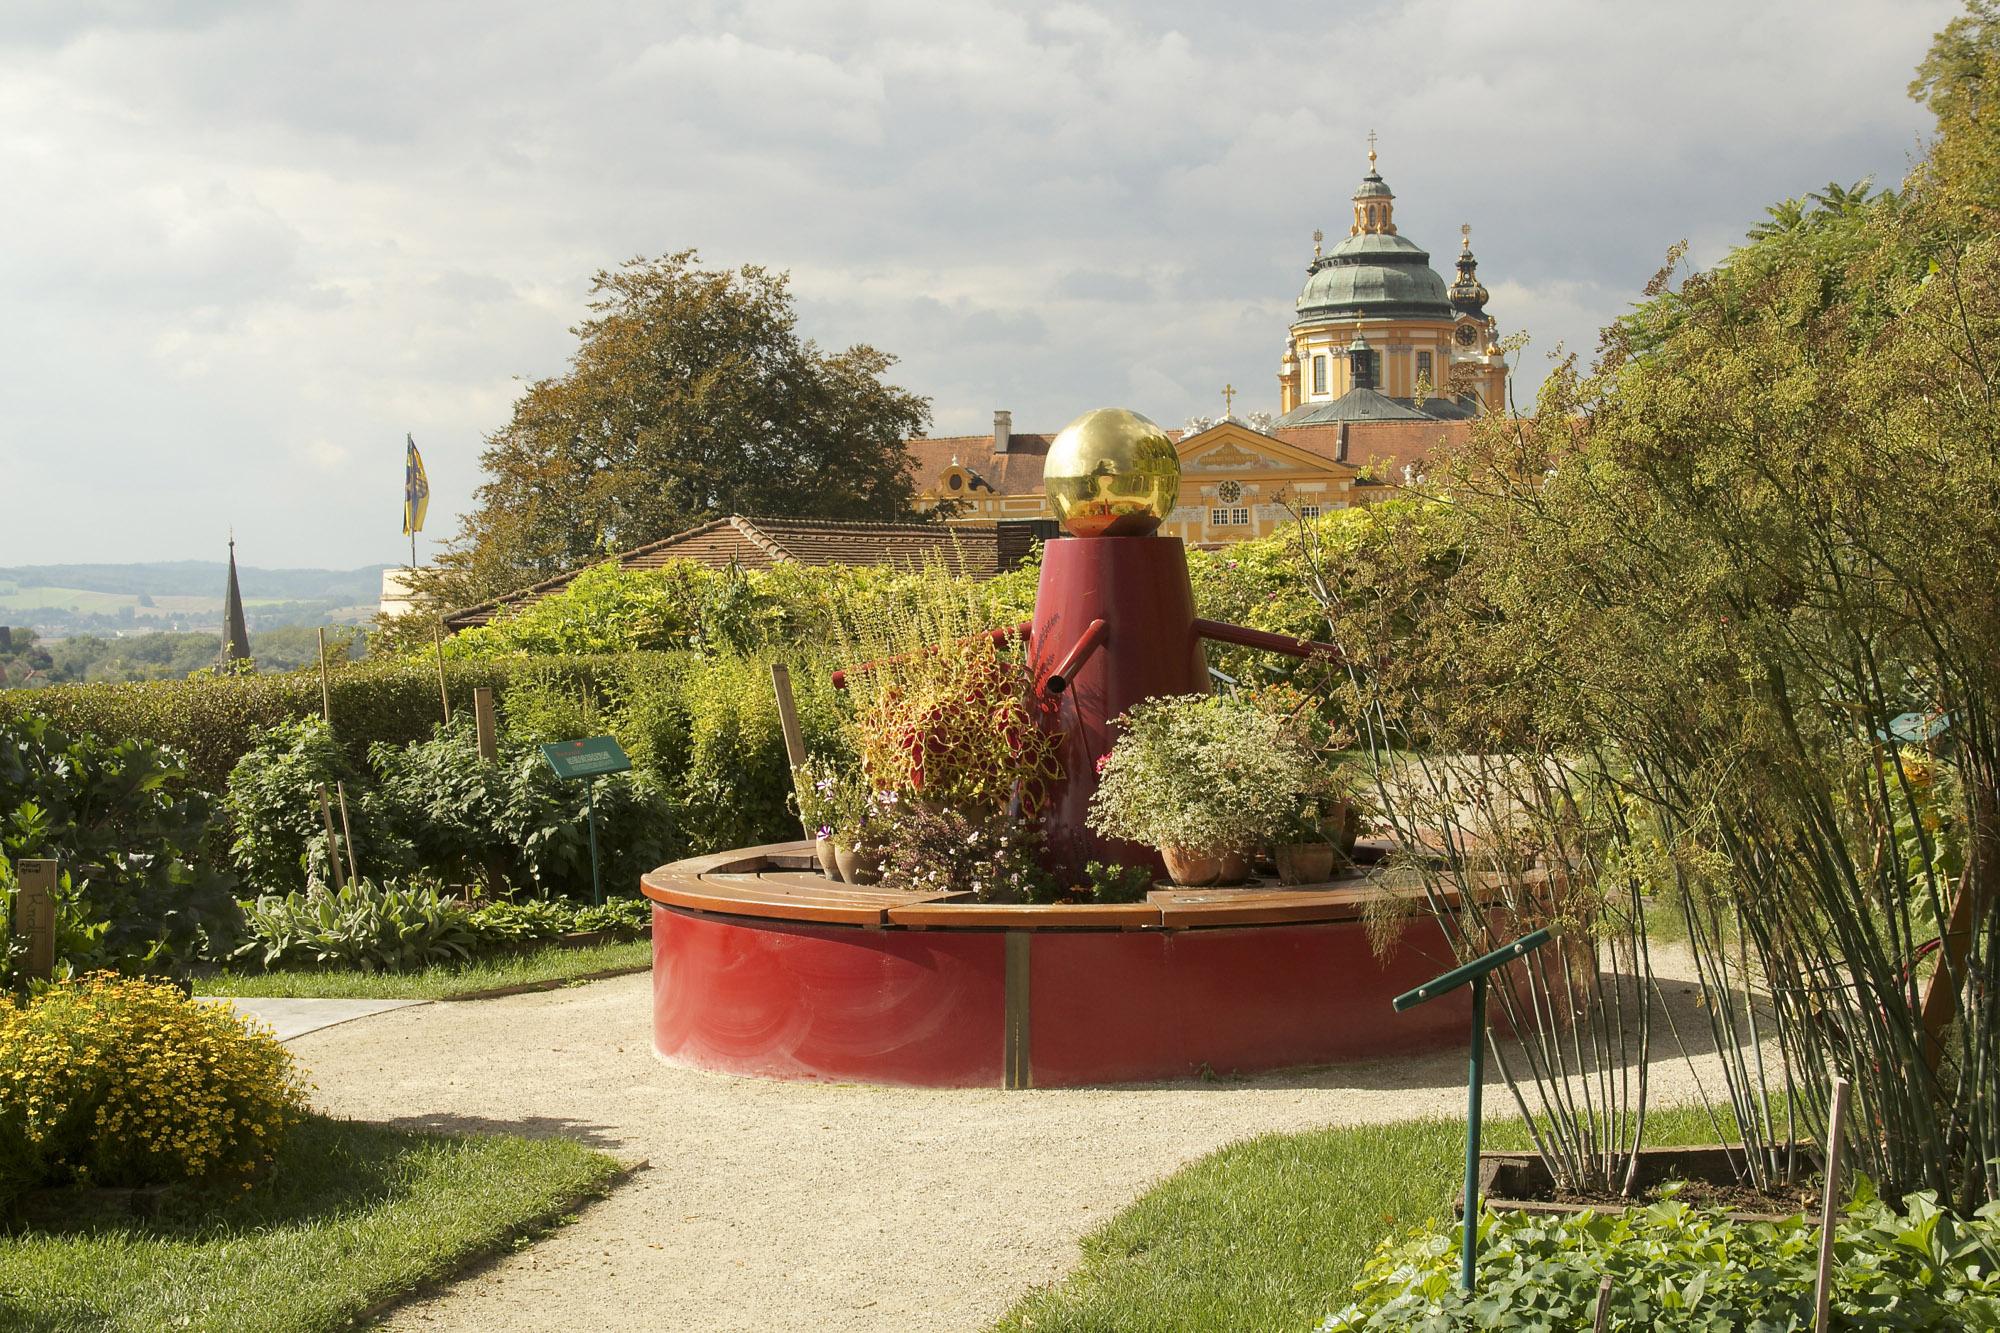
234;879;480;973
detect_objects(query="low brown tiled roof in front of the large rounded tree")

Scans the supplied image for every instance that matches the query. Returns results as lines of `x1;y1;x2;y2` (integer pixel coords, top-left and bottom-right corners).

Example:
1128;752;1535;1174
444;514;1034;630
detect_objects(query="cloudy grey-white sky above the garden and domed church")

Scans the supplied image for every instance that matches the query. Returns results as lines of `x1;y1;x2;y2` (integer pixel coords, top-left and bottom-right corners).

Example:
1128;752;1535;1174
0;0;1956;566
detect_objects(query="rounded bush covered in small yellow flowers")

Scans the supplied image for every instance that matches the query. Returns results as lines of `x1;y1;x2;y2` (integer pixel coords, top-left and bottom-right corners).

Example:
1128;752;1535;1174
0;975;308;1195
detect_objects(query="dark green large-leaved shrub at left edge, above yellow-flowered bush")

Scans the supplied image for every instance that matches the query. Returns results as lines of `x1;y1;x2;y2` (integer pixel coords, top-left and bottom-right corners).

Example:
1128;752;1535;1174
0;717;236;973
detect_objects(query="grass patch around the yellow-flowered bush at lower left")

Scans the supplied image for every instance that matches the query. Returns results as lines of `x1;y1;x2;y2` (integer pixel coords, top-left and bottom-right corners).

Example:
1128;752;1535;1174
0;1117;618;1333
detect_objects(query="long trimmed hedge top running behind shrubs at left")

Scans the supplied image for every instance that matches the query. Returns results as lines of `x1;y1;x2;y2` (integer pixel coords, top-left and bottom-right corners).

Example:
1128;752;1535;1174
0;652;672;791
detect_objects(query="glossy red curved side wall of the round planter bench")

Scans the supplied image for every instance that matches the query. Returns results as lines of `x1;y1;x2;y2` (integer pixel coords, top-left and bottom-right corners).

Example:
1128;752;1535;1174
652;905;1470;1087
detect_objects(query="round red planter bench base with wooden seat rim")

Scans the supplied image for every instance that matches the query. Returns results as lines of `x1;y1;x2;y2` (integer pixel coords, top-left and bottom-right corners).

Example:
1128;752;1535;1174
644;845;1470;1087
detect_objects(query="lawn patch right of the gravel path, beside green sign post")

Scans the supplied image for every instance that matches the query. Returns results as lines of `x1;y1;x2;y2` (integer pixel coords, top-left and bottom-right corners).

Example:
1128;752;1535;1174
998;1111;1714;1333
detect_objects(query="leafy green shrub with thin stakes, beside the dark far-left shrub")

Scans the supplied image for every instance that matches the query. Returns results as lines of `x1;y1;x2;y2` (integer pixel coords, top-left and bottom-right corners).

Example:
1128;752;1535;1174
222;717;366;893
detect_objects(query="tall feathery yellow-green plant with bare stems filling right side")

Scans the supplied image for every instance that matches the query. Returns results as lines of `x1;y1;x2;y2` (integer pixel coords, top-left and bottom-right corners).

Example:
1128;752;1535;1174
1332;4;2000;1211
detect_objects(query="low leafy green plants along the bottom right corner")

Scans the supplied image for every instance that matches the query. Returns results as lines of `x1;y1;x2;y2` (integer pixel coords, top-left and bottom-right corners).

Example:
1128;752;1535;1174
1320;1181;2000;1333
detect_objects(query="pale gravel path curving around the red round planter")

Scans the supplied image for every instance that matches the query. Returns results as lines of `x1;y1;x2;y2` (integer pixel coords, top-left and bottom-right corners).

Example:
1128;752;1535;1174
292;944;1736;1333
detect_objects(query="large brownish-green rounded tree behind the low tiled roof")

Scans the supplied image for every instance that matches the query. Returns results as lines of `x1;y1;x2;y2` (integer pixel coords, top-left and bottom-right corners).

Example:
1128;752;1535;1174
418;250;930;606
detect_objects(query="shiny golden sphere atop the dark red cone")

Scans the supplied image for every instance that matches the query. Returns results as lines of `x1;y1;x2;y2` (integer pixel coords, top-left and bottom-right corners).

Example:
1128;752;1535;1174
1042;408;1180;536
